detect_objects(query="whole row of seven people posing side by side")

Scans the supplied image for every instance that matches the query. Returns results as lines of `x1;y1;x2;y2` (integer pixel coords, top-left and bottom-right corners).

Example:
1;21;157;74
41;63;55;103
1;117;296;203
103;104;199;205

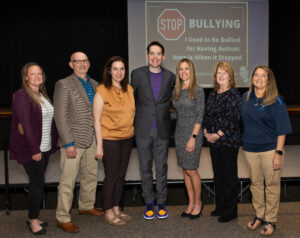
10;41;292;235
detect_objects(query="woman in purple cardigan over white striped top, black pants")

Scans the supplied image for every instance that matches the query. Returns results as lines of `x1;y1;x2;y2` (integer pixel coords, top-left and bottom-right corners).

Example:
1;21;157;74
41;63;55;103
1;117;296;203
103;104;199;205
10;63;58;235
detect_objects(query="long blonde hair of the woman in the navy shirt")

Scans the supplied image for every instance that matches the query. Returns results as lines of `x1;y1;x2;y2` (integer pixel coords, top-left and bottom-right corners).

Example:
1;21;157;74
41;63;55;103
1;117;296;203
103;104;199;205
246;65;278;106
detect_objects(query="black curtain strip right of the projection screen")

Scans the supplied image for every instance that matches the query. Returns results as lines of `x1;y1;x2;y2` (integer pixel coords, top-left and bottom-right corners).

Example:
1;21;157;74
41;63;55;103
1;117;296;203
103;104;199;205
269;0;300;104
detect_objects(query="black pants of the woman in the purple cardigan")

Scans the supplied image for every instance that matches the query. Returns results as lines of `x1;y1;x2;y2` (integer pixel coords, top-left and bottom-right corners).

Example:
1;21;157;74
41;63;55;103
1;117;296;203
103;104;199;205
23;152;50;219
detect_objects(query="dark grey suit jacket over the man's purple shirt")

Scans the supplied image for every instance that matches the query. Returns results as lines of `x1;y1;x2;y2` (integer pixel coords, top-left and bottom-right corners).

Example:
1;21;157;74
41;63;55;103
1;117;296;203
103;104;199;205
130;66;175;140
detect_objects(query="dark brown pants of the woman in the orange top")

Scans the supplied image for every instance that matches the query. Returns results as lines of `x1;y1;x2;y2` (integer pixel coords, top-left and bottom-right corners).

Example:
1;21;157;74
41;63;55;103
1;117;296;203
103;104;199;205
103;138;133;210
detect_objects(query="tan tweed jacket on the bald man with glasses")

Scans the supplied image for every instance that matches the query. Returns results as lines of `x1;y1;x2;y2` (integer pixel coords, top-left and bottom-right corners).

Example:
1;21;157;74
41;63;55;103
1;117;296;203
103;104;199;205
53;74;98;149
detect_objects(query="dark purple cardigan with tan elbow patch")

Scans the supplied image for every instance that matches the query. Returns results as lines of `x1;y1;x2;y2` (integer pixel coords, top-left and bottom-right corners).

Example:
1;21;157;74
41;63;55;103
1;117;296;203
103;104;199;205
9;89;58;164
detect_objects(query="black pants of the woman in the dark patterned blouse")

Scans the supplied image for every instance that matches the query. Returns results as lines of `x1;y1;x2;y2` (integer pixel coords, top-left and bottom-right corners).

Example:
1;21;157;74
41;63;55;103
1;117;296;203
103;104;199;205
210;146;239;219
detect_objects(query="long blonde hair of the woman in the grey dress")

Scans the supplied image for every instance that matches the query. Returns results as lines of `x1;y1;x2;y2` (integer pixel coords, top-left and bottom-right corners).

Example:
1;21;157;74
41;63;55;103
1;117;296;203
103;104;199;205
173;58;197;101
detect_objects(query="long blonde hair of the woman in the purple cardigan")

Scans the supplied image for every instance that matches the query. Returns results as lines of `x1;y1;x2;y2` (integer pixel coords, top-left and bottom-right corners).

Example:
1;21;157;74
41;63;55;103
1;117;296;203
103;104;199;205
21;62;52;106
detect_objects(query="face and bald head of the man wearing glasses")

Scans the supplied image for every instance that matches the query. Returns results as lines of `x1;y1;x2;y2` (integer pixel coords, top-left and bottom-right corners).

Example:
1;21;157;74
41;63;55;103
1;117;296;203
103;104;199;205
69;52;90;78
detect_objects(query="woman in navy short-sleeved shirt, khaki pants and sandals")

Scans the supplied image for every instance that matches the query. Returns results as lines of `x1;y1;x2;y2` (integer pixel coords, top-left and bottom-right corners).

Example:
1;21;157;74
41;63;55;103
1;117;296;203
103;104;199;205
242;65;292;236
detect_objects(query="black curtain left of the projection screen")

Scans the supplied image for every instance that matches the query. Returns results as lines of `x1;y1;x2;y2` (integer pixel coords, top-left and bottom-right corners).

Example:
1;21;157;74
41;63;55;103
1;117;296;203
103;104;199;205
0;0;128;107
